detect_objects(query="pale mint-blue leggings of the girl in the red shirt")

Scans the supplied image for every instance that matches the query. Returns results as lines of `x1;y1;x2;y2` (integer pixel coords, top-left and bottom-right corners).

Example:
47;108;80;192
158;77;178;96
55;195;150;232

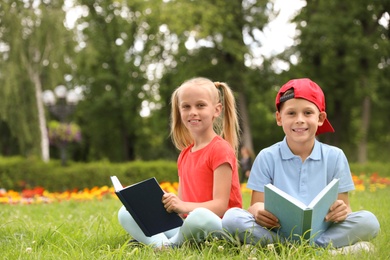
118;206;222;247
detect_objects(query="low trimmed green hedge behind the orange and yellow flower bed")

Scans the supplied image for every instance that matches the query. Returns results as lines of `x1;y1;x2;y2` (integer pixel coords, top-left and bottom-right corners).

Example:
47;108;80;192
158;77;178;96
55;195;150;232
0;157;390;191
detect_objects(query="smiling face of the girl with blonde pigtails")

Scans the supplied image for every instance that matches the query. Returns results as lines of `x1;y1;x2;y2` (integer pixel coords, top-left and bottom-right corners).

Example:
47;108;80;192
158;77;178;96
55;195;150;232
179;85;222;135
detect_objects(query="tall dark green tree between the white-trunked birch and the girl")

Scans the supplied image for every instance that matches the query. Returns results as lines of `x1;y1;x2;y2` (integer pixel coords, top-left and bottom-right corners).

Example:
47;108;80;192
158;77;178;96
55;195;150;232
75;0;168;161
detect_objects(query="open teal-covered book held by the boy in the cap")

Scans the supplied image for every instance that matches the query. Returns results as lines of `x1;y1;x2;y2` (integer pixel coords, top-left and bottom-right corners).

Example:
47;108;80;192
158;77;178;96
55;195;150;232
264;179;339;243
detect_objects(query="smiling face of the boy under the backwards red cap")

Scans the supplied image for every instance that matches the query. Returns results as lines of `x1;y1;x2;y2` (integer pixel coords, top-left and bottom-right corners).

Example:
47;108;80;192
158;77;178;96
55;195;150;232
276;98;326;142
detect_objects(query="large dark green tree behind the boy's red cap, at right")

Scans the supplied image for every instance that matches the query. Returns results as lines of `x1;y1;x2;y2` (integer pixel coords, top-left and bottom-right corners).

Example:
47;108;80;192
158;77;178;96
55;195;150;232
288;0;390;162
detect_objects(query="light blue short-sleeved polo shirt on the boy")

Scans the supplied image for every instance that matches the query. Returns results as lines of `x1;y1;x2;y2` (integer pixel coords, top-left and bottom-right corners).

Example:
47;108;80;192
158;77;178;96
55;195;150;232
247;137;355;205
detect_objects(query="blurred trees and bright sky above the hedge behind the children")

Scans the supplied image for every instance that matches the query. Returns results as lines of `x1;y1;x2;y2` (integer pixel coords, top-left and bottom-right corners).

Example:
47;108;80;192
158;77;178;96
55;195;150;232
0;0;390;165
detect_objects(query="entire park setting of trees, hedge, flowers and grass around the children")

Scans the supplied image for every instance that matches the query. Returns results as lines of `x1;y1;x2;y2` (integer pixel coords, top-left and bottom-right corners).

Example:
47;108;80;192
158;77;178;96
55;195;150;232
0;0;390;259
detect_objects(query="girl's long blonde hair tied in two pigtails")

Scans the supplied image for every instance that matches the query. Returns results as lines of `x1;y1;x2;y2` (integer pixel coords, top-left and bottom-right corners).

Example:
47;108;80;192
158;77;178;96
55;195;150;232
171;77;240;154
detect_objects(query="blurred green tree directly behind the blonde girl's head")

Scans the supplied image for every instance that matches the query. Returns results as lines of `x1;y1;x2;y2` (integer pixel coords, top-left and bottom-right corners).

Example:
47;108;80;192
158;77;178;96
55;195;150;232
150;0;273;153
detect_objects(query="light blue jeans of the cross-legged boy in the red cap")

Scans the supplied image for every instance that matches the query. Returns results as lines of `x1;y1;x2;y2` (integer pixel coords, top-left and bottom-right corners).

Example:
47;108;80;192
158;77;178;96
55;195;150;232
222;208;379;248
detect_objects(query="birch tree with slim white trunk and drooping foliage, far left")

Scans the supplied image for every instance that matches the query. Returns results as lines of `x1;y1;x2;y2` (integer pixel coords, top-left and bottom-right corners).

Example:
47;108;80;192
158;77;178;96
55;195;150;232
0;0;75;161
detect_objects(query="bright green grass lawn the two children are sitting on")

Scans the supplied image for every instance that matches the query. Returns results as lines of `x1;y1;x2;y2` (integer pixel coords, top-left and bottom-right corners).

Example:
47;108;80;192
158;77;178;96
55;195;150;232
0;188;390;260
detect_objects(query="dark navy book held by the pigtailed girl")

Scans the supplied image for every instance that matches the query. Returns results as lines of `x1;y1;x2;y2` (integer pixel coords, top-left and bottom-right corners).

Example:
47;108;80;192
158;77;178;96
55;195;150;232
111;176;183;237
